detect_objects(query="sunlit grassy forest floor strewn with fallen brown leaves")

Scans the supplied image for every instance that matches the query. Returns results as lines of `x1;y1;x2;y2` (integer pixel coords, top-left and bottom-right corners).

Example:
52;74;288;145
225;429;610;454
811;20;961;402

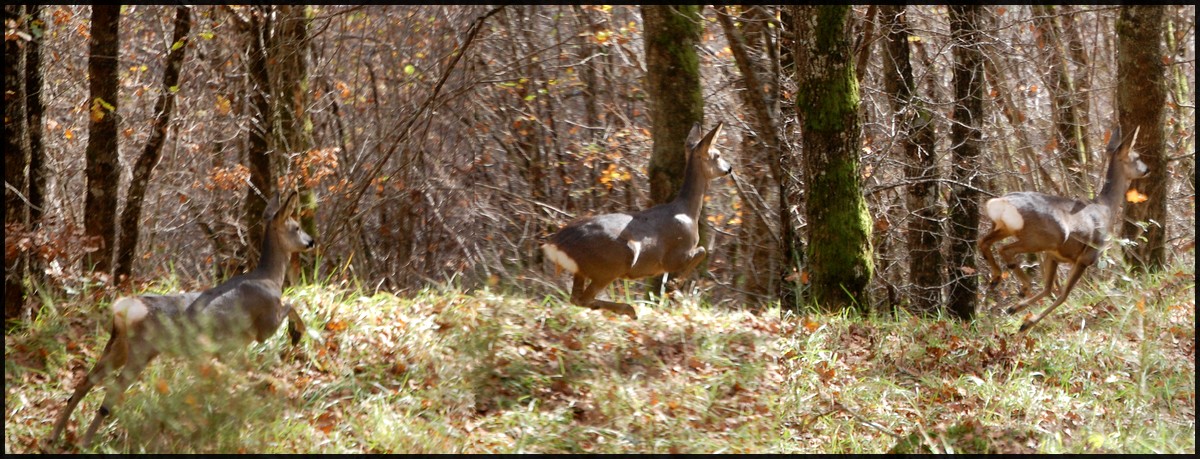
5;259;1195;454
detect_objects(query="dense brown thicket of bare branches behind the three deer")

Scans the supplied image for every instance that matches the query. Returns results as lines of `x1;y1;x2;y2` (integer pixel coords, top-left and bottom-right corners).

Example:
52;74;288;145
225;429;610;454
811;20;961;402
5;5;1195;315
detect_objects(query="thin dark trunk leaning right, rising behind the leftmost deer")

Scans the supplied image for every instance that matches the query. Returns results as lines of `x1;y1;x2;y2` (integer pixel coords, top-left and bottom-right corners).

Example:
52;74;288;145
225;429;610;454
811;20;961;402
113;6;192;282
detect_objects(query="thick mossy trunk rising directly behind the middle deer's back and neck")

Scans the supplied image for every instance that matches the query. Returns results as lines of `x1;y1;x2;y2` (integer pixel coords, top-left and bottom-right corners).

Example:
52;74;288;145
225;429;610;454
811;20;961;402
642;5;708;292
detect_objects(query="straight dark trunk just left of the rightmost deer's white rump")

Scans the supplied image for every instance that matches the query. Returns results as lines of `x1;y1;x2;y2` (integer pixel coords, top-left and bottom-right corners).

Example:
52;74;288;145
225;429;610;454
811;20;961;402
947;5;984;320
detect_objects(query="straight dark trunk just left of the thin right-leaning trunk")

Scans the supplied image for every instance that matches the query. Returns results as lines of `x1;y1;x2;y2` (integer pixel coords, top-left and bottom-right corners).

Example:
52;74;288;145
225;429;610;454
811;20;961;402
84;5;121;273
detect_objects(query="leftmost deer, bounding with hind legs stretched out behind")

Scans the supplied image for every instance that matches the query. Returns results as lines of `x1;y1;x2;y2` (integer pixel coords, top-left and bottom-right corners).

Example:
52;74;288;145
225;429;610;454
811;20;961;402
48;192;316;447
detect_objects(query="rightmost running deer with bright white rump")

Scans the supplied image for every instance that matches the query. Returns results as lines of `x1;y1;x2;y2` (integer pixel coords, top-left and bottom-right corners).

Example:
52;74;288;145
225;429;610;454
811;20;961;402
979;126;1150;332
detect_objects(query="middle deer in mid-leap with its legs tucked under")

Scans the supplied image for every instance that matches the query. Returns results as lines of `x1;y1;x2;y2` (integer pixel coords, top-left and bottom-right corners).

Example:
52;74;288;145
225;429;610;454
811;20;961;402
541;123;733;318
